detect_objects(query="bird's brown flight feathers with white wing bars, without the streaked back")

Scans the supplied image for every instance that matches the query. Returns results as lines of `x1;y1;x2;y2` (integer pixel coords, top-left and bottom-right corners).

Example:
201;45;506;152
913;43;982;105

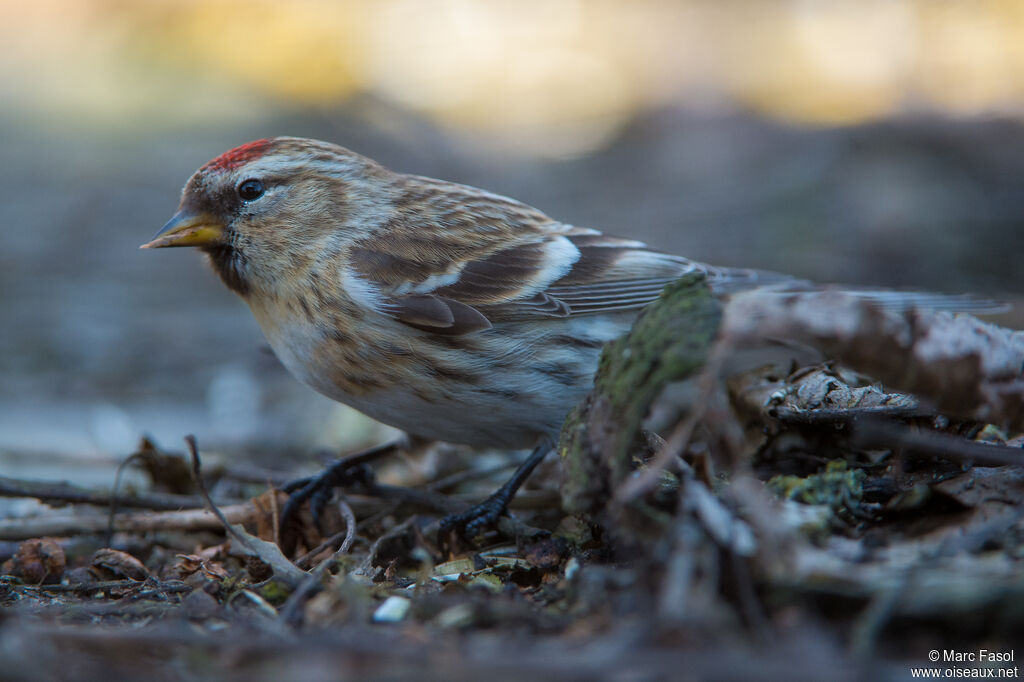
350;228;701;334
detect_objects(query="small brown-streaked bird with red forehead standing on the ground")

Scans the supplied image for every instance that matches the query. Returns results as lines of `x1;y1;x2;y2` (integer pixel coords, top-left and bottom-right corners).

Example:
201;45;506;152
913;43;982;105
142;137;987;523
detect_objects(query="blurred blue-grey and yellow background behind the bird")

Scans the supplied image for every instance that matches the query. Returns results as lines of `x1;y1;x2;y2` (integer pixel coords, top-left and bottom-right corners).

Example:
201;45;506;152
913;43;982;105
0;0;1024;482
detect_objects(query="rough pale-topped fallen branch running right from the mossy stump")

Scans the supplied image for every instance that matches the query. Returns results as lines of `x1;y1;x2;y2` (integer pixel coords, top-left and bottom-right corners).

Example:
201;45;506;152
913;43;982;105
722;290;1024;431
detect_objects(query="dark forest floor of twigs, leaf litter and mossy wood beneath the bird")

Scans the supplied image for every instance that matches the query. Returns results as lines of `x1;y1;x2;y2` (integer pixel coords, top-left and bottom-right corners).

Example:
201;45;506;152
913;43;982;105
0;278;1024;682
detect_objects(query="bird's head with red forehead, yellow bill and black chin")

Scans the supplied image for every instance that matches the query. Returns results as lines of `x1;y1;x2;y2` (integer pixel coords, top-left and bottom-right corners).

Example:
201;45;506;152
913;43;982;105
141;137;390;296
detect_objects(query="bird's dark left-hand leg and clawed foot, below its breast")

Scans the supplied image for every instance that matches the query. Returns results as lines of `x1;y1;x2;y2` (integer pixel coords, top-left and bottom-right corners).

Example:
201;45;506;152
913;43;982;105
281;437;411;544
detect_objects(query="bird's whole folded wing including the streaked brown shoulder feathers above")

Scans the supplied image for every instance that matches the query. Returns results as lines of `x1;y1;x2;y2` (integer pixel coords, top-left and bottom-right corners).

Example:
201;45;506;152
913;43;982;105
348;182;733;335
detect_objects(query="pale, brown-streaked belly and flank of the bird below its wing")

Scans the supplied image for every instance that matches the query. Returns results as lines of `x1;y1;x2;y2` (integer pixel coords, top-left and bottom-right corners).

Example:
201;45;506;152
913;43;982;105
250;315;600;450
